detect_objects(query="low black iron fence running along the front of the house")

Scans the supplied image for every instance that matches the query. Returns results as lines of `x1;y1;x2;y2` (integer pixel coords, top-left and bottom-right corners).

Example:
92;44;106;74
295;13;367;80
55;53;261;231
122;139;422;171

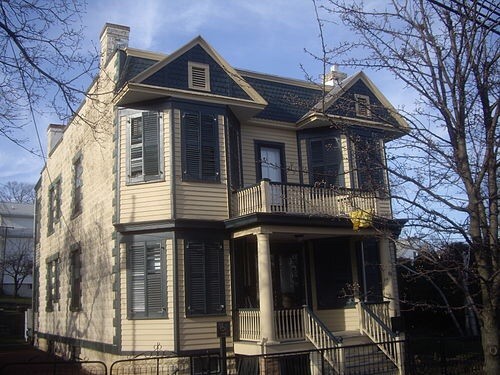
0;338;483;375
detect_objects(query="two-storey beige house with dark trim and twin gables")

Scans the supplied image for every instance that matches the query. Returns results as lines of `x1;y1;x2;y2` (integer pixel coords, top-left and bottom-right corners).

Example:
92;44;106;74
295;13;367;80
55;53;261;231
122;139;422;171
35;24;407;374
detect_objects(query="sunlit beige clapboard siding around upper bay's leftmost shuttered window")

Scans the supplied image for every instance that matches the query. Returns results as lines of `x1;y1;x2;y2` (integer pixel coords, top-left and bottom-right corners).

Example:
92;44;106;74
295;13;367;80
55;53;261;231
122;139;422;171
120;110;172;223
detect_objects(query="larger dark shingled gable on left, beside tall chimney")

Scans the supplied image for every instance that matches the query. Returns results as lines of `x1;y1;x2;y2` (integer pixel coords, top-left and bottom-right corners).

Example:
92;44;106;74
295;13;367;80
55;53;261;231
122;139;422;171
119;36;267;110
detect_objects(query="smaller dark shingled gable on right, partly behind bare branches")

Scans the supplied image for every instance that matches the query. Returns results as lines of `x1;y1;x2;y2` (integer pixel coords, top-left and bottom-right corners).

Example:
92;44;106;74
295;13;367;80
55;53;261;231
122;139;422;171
297;71;409;132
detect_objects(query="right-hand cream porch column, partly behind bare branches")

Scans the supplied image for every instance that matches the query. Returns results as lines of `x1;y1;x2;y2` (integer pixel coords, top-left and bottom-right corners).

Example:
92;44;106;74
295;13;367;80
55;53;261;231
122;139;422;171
379;237;399;316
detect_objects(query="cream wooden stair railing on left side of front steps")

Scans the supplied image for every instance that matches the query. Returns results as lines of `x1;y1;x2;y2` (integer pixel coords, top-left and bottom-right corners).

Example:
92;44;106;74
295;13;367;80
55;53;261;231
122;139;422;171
303;306;345;374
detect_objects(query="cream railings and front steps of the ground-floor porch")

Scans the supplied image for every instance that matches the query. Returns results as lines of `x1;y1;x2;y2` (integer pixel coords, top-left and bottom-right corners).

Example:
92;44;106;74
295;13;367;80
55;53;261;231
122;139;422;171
234;302;404;374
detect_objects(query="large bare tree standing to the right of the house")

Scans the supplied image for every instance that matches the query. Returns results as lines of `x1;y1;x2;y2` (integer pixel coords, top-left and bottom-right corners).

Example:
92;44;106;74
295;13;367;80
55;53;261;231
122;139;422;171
315;0;500;374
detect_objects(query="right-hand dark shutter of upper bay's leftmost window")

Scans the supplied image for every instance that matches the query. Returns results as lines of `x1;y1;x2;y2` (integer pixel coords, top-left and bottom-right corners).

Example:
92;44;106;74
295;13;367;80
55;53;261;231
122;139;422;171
142;112;160;181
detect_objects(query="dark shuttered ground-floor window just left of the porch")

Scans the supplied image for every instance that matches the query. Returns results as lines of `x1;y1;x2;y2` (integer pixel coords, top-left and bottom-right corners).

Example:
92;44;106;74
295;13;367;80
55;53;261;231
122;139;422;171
185;241;226;315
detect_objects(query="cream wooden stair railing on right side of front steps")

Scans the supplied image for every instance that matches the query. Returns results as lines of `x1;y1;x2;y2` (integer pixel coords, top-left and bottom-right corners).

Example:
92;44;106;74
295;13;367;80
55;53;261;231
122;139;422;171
360;303;404;374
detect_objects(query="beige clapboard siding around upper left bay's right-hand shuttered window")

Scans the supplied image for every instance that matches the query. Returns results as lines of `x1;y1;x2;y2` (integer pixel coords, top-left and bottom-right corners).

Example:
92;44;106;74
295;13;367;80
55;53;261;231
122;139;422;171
173;110;229;220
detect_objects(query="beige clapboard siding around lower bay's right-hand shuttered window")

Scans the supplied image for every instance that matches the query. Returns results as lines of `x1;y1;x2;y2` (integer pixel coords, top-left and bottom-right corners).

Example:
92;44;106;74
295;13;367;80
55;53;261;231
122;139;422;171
177;239;234;350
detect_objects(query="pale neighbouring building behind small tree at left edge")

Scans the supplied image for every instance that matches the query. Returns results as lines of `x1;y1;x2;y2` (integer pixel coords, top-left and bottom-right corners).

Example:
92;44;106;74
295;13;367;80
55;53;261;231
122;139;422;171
0;202;34;297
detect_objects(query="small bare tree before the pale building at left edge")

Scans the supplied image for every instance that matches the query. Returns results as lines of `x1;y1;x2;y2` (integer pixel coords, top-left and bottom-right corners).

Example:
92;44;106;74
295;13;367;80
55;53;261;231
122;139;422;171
0;239;33;297
